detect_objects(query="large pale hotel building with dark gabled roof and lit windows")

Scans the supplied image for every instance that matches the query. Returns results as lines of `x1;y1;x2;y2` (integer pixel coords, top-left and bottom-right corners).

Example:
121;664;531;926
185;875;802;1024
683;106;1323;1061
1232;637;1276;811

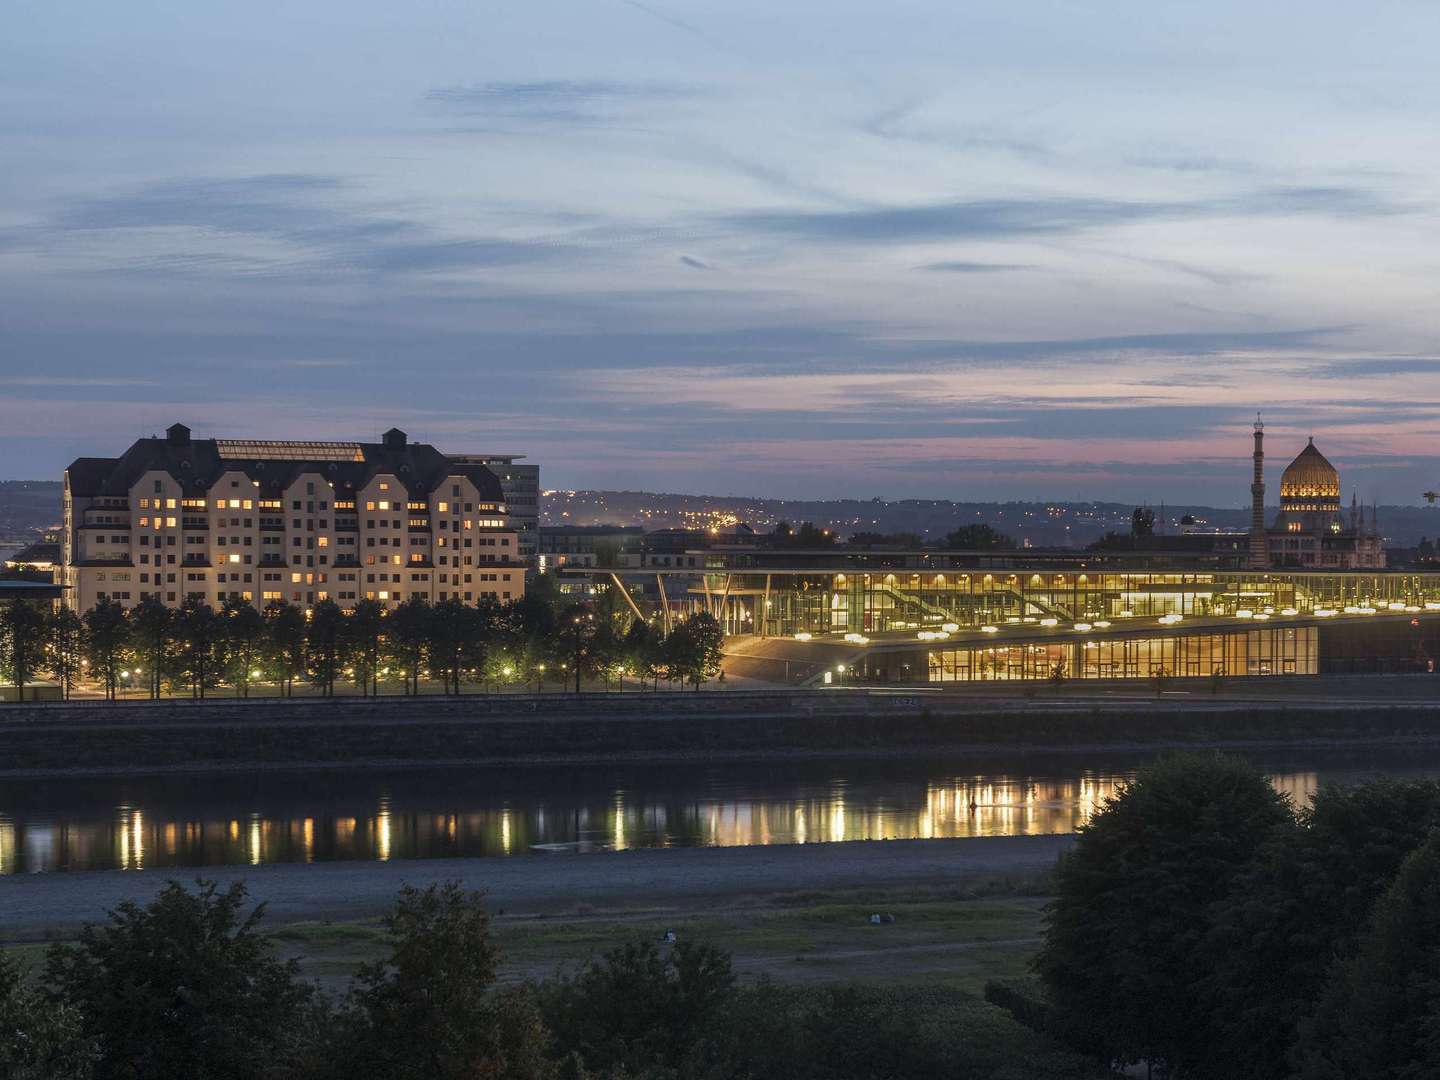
62;423;526;611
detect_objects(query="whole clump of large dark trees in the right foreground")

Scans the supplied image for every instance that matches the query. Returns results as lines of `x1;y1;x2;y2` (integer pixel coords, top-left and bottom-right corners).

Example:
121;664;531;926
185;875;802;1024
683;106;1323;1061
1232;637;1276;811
1017;756;1440;1080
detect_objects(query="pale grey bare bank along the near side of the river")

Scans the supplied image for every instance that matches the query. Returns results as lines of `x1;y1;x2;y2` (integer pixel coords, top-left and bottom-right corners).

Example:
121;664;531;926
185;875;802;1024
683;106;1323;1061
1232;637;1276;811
0;837;1074;942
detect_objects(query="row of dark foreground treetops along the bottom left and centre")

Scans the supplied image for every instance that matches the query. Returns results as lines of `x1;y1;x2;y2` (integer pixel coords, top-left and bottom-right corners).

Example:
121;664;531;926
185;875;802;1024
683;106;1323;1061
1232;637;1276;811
0;883;1100;1080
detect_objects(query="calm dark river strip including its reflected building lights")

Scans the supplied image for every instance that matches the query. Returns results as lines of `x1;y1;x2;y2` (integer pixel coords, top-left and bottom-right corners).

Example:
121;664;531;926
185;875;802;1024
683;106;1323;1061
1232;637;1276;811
0;750;1416;874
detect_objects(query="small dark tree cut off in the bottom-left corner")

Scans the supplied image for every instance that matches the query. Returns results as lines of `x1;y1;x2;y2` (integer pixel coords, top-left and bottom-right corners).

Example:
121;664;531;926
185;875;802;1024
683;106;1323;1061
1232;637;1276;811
0;952;99;1080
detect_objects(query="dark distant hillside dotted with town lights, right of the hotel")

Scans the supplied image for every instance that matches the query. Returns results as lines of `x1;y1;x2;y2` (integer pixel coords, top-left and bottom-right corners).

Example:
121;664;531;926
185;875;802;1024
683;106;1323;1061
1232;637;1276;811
540;491;1440;547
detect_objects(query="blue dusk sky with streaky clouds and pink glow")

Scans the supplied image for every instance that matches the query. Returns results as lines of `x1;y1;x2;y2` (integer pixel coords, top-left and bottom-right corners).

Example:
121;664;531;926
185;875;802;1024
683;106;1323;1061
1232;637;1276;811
0;0;1440;505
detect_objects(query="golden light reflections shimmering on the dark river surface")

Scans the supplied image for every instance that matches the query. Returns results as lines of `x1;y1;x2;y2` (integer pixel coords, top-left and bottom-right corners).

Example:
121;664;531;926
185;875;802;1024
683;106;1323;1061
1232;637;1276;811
0;772;1322;874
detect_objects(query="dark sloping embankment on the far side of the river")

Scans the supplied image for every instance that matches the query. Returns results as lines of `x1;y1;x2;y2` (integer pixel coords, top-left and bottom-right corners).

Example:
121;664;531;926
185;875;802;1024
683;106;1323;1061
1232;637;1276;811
0;677;1440;778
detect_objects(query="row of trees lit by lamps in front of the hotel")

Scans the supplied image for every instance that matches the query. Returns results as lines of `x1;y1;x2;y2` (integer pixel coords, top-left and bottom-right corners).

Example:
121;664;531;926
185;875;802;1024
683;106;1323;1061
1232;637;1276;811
0;596;723;700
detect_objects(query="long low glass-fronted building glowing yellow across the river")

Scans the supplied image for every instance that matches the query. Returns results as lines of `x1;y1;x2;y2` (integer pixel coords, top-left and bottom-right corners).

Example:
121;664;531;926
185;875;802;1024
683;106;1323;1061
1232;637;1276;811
578;550;1440;684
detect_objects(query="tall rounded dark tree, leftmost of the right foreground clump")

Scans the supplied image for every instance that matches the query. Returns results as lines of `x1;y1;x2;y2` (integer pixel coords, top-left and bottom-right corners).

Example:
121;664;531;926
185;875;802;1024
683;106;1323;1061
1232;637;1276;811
1035;755;1295;1068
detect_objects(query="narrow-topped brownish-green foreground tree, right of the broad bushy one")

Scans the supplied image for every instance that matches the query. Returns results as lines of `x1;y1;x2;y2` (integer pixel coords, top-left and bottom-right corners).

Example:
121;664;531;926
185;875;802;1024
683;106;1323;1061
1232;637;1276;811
321;881;553;1080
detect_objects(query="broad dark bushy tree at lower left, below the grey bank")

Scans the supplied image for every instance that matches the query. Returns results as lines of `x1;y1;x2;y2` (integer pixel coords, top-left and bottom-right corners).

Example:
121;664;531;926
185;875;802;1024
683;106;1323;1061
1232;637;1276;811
46;881;311;1080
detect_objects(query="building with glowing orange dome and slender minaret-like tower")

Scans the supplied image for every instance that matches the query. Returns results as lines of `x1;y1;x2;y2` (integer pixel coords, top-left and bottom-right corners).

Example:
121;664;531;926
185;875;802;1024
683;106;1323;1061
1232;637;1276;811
1251;423;1385;570
